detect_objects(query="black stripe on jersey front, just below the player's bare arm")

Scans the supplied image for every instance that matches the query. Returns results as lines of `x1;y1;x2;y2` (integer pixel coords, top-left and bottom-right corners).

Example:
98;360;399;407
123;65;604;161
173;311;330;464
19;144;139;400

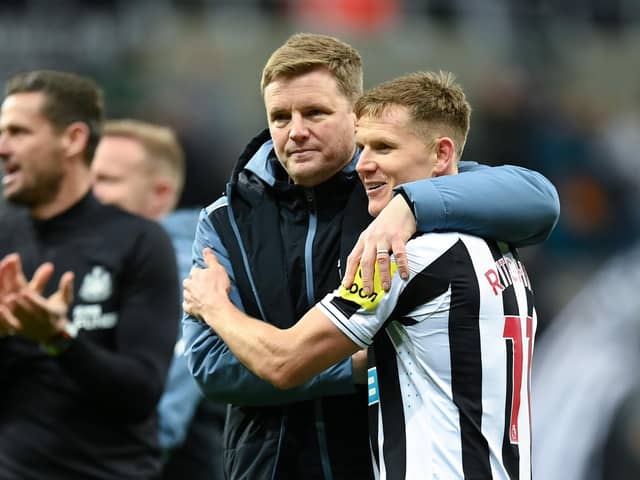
369;331;407;480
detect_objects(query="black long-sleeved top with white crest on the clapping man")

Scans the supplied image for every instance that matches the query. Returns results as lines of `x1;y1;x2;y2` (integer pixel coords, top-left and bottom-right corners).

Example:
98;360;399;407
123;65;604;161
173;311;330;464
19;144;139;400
0;194;180;480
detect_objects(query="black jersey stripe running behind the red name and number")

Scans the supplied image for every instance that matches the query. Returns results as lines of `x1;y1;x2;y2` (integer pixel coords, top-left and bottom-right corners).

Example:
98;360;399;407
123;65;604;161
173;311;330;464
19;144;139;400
487;241;529;480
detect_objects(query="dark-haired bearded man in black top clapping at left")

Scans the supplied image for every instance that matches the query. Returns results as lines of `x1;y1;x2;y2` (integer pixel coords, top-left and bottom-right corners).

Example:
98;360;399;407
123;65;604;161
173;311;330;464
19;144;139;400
0;71;179;480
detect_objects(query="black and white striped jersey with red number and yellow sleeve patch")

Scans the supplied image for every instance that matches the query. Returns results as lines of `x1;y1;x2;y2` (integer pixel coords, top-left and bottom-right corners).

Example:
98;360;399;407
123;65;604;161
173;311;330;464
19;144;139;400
318;233;536;480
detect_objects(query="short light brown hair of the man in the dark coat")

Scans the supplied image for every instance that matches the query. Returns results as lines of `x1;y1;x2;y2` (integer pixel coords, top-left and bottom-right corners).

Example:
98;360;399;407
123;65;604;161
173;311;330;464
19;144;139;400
260;33;362;103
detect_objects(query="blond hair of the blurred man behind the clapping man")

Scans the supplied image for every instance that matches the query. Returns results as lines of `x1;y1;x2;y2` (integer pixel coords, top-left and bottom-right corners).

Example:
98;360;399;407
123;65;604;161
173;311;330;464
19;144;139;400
102;119;185;209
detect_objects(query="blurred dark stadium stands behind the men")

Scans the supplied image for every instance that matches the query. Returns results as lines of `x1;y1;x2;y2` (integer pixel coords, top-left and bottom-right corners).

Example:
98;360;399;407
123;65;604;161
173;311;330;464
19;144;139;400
0;0;640;402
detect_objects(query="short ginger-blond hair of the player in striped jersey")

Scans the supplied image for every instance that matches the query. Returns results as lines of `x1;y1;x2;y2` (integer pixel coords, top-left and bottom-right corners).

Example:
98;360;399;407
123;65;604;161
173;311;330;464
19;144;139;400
355;71;471;160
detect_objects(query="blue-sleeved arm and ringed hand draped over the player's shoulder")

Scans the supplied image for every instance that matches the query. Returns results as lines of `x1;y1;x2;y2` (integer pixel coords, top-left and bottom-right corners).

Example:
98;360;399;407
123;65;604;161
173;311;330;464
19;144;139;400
344;162;560;291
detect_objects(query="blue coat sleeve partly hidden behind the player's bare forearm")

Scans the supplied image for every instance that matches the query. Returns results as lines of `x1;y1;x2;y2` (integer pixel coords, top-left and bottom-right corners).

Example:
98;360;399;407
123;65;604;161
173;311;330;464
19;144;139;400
182;202;355;406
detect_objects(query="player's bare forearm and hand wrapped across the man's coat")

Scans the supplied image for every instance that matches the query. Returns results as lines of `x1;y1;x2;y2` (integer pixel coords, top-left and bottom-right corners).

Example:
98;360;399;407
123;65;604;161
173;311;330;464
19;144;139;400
183;249;360;389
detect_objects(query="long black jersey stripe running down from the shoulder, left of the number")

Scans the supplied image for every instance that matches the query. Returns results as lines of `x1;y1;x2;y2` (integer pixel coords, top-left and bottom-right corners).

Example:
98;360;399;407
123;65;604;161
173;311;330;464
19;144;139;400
425;240;491;479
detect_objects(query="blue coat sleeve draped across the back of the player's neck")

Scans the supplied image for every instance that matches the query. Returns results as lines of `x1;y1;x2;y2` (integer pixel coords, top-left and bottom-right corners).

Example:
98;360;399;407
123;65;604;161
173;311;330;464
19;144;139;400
396;162;560;247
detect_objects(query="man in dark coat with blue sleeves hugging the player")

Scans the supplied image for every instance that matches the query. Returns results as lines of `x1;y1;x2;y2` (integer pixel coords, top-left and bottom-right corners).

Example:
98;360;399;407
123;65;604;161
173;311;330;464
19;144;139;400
183;34;558;480
